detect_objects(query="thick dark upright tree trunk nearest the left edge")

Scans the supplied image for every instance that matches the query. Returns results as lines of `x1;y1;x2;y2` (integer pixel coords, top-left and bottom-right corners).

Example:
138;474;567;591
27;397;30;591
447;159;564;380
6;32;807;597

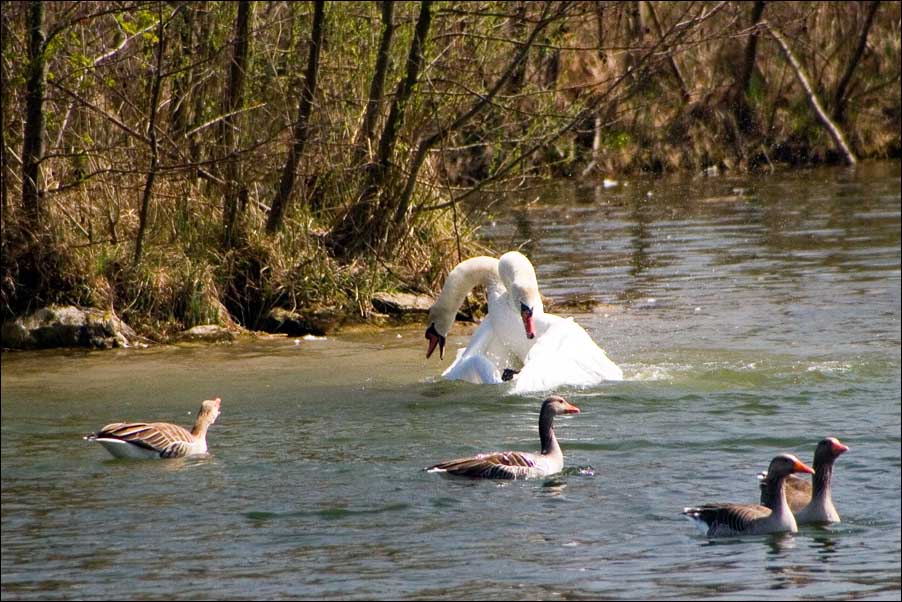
22;0;46;227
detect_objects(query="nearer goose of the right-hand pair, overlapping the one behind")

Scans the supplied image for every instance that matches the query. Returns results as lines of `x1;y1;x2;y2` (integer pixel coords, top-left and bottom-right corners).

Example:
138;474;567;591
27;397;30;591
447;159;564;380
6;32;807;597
683;454;814;537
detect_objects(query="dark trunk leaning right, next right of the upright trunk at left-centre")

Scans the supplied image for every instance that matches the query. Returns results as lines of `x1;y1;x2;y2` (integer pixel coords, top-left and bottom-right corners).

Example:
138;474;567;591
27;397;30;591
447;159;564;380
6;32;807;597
266;0;326;235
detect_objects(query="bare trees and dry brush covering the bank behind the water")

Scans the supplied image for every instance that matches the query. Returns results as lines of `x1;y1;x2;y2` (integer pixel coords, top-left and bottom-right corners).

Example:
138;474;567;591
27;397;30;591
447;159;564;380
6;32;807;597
0;0;902;339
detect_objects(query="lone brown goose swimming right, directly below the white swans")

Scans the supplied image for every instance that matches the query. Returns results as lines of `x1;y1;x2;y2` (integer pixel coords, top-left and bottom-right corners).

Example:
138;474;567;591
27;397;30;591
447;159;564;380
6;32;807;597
425;395;579;479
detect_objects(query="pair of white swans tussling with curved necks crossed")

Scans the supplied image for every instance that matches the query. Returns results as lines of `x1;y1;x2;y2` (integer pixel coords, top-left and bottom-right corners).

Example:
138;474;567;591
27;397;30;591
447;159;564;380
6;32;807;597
426;251;623;393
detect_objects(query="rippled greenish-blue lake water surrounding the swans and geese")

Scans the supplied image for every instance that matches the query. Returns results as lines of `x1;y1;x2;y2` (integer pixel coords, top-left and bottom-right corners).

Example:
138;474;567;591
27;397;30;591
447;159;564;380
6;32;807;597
2;163;902;600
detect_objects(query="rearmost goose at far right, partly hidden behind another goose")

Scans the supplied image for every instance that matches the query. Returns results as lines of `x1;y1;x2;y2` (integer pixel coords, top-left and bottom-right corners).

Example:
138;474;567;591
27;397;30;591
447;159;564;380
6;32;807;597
759;437;849;525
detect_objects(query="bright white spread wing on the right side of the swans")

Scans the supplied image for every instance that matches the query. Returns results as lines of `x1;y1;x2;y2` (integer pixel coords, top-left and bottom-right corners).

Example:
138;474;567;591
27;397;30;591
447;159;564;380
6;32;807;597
512;314;623;393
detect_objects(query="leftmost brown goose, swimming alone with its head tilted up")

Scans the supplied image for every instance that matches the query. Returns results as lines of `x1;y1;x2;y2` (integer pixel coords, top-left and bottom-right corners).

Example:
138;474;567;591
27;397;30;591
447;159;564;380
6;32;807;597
85;397;222;459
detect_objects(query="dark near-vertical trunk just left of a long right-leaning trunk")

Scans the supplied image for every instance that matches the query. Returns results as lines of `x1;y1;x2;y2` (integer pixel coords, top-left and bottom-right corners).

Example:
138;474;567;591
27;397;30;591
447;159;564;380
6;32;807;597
220;0;253;249
